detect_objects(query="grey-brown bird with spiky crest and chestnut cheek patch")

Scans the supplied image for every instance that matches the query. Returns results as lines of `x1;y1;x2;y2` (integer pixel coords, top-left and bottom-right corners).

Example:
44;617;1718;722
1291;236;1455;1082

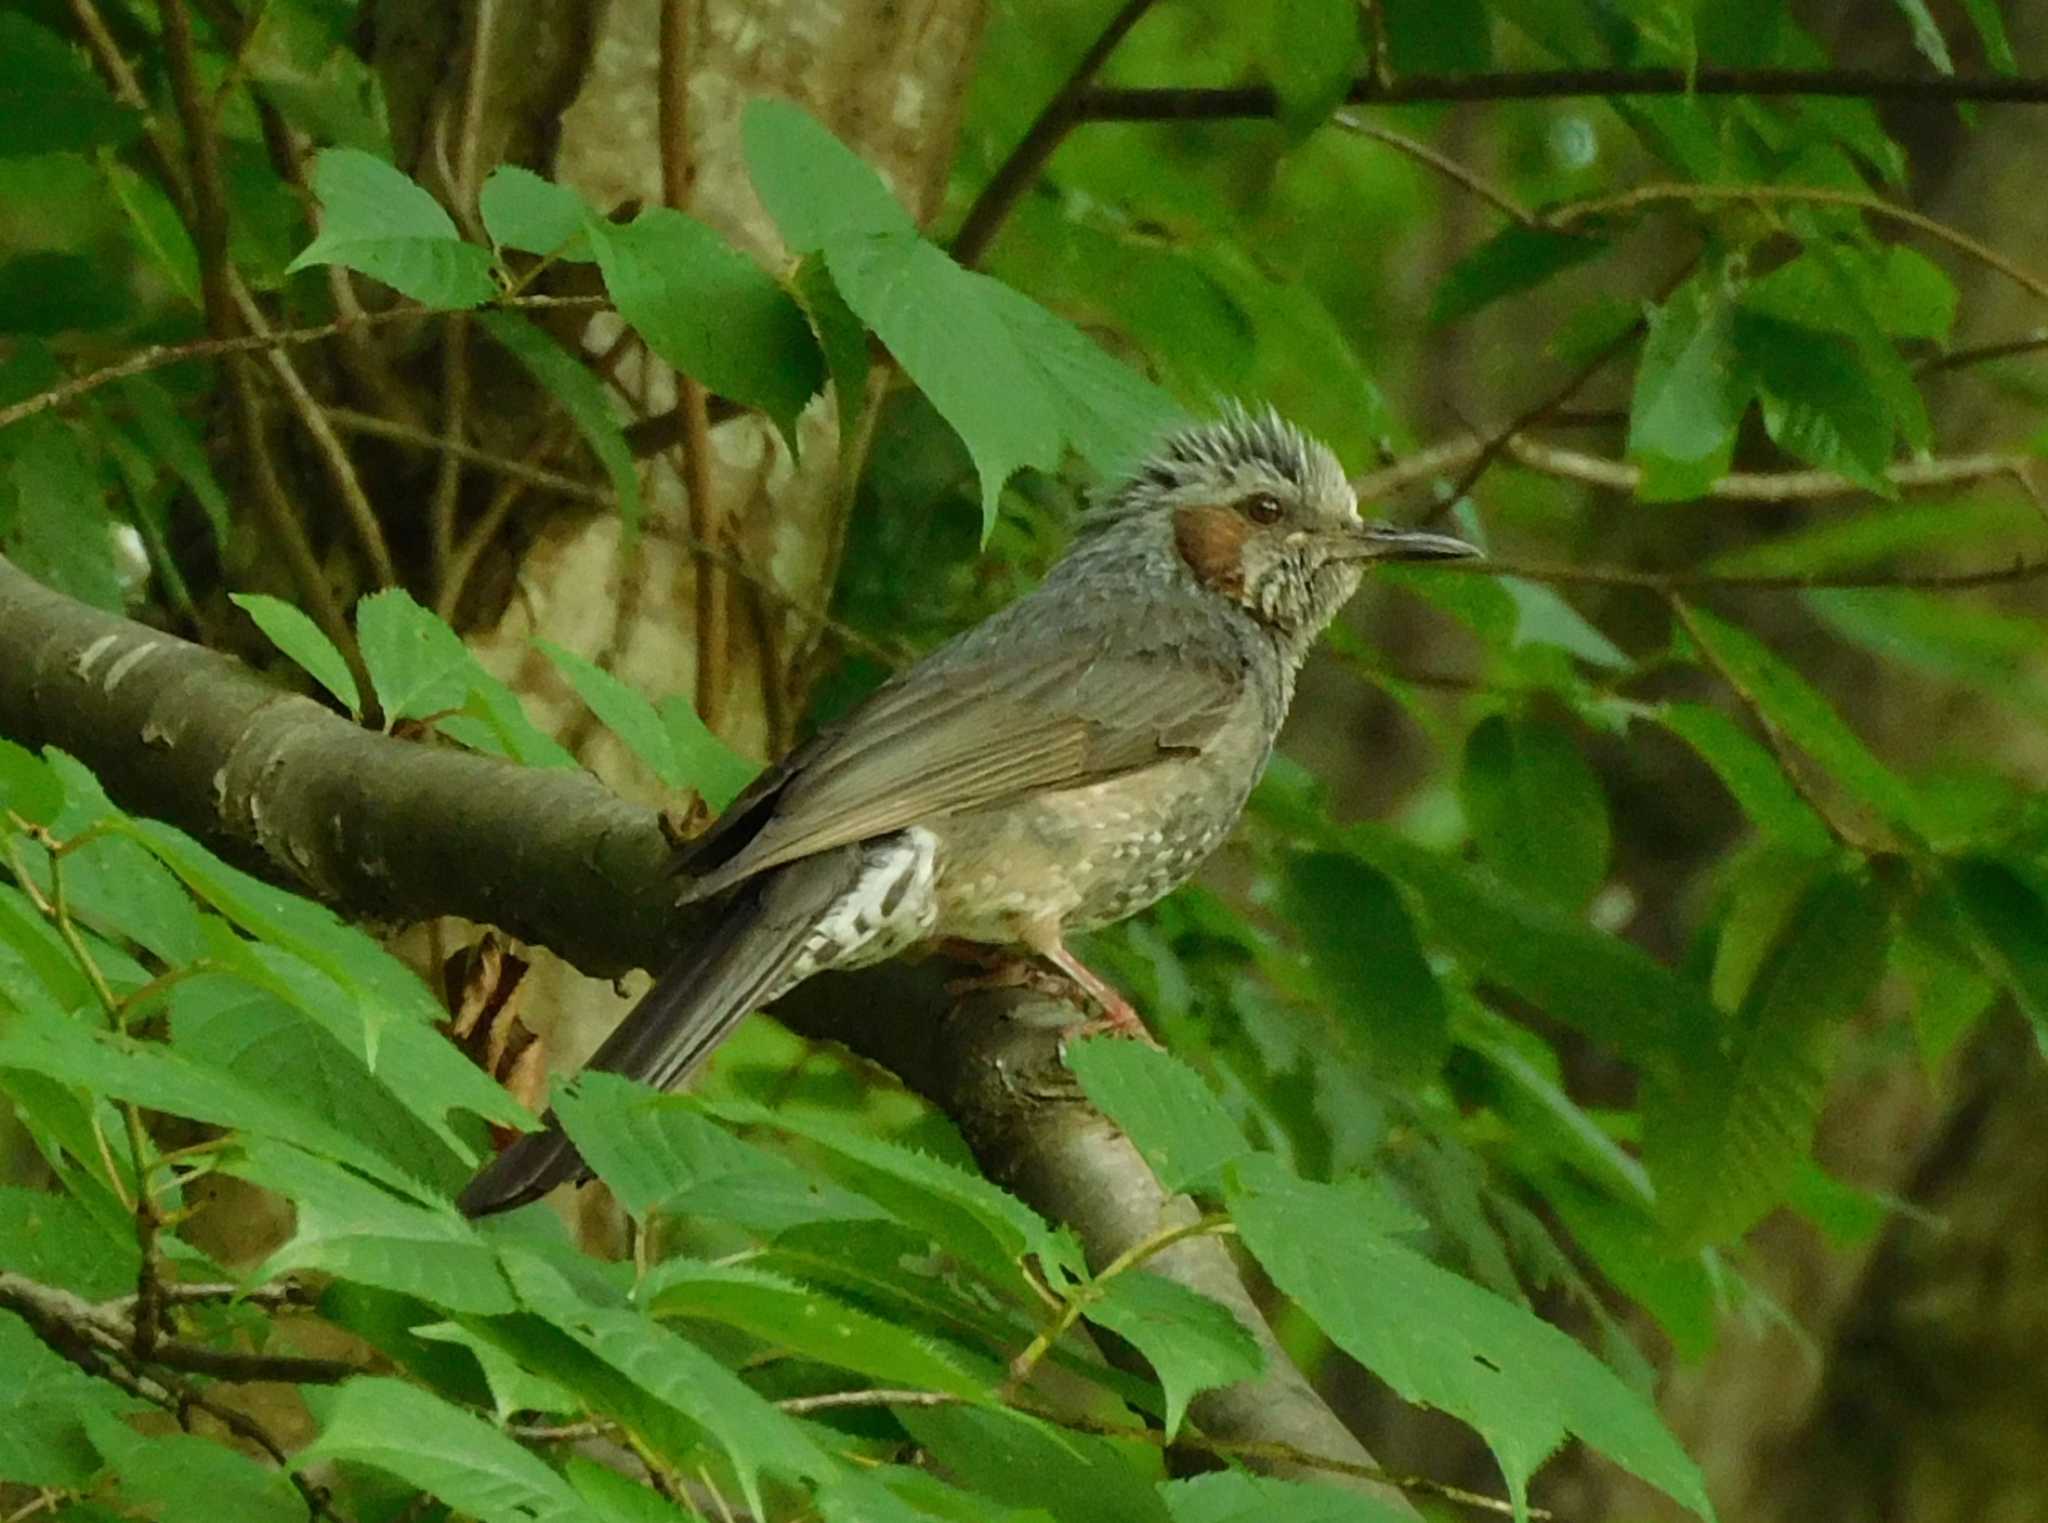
461;409;1477;1216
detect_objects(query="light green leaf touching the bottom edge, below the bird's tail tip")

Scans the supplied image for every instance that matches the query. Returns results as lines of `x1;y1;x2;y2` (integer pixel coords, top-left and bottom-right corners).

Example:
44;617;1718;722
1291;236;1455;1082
295;1376;590;1523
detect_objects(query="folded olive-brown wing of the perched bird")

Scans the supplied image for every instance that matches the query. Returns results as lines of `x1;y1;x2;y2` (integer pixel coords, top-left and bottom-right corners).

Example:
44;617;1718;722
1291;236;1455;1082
684;647;1245;899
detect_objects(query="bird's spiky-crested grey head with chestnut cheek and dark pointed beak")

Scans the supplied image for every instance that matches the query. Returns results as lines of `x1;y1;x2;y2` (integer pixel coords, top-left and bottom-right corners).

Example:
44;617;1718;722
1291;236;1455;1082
1104;407;1479;641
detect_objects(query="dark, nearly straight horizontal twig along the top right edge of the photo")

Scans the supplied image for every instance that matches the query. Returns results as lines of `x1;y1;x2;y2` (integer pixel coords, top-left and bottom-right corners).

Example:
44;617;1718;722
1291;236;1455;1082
1073;70;2048;121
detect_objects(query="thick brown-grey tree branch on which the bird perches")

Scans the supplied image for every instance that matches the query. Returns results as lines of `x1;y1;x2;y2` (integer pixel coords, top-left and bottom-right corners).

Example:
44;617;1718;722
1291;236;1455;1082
0;559;1407;1509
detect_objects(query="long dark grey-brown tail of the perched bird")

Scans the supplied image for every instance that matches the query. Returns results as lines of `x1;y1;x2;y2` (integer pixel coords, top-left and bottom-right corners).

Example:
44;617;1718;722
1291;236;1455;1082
457;847;860;1216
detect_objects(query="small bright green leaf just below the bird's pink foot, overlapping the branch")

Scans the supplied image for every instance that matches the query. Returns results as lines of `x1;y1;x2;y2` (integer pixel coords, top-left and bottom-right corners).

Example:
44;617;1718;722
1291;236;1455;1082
1067;1036;1251;1193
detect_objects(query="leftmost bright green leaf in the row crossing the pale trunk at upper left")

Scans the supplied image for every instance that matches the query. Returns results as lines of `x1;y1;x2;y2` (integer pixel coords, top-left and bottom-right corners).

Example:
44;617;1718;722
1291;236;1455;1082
285;147;498;309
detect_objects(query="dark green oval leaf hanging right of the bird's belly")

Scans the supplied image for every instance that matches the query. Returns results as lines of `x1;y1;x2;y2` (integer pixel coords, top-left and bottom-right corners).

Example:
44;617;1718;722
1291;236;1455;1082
1282;852;1450;1081
